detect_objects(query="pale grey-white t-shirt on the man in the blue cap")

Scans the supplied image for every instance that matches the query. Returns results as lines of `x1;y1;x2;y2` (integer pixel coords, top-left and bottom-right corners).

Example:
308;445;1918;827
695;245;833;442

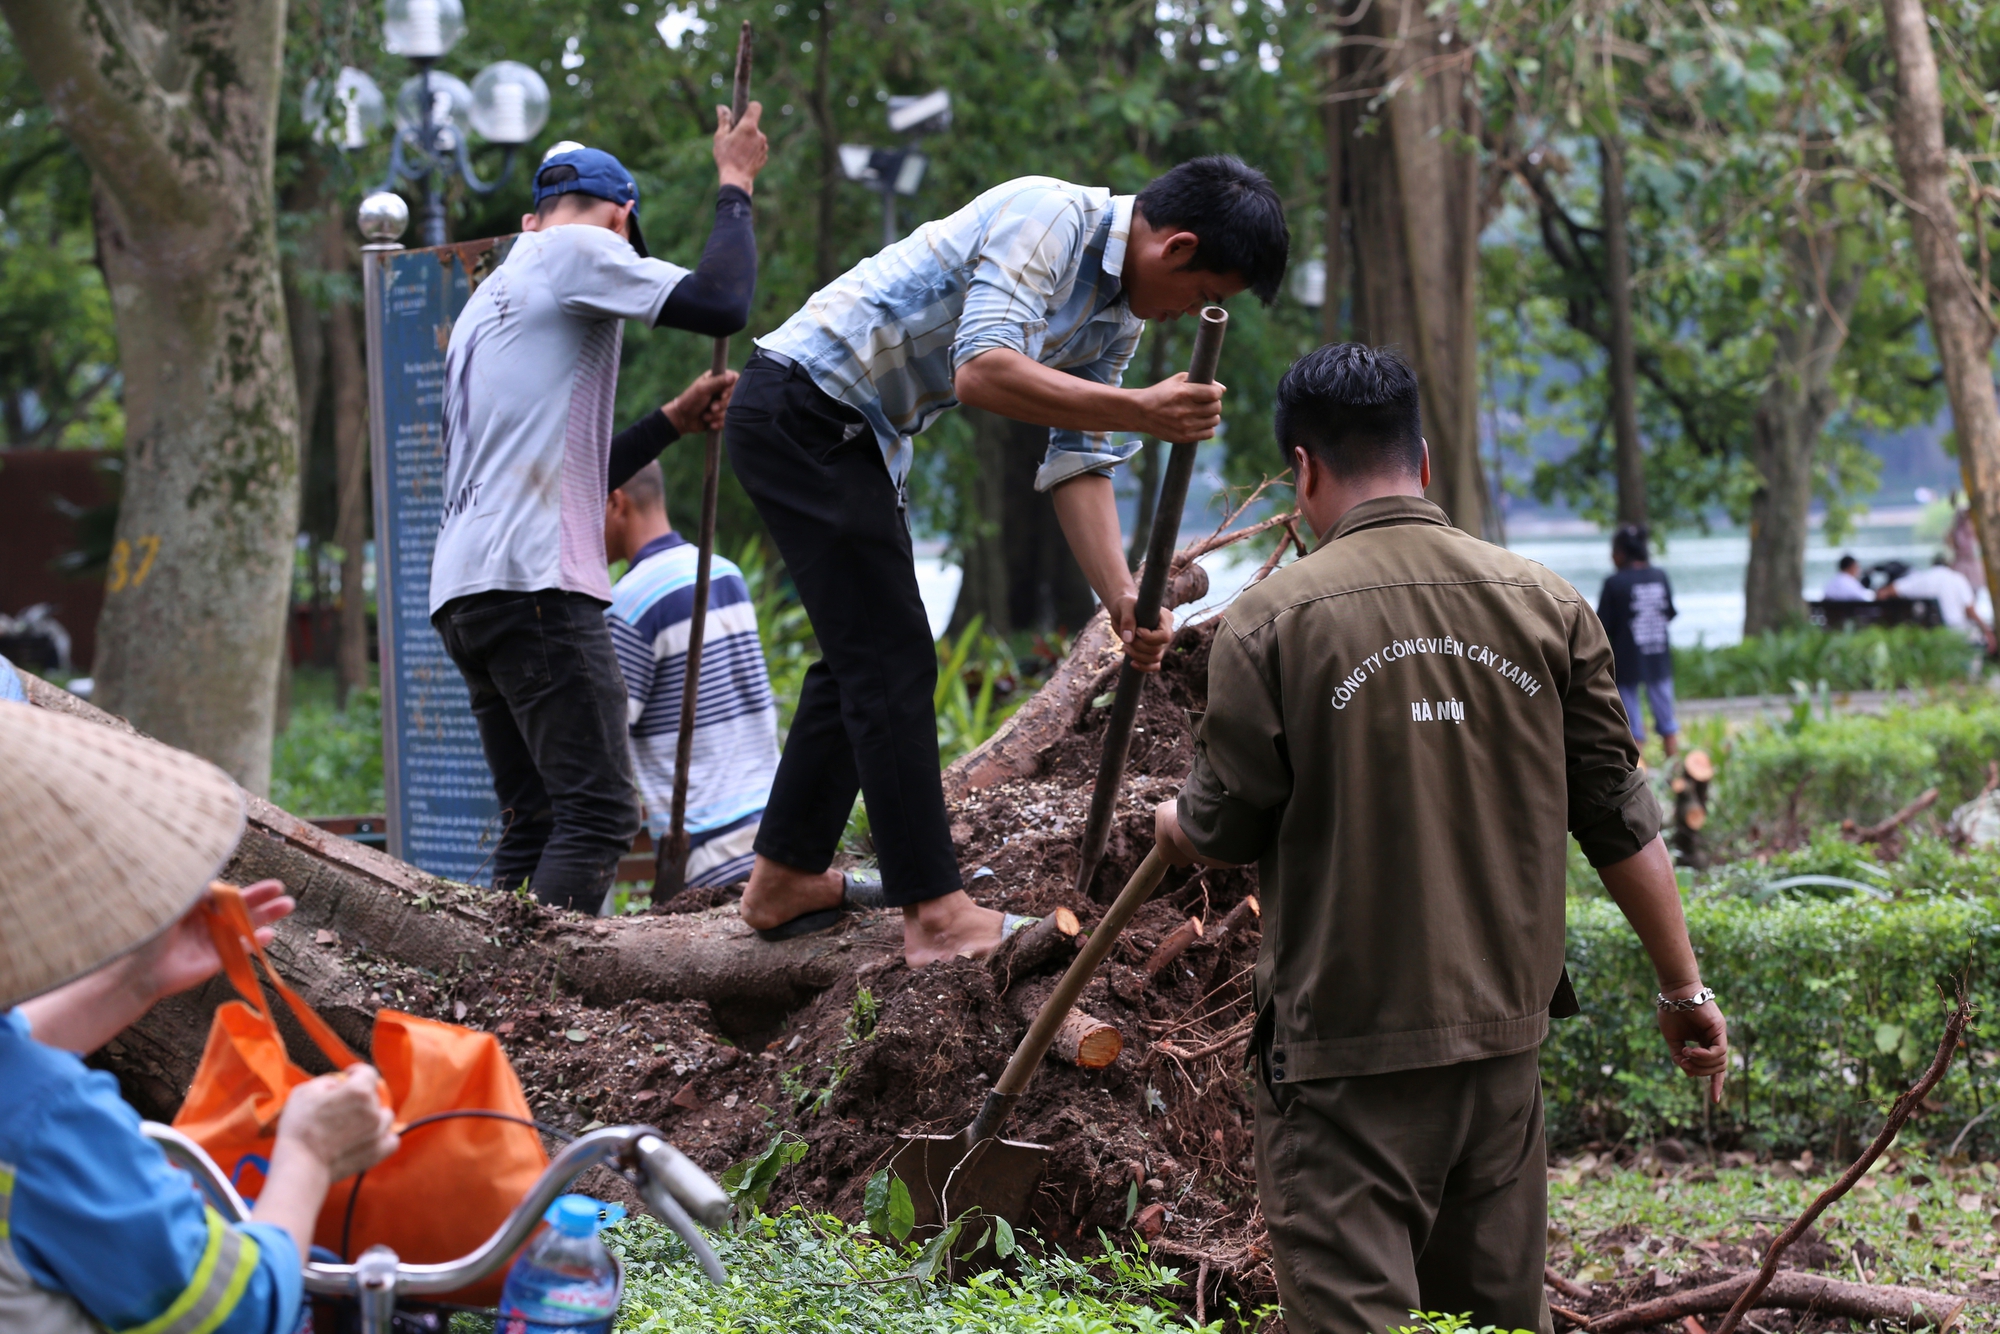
430;224;688;614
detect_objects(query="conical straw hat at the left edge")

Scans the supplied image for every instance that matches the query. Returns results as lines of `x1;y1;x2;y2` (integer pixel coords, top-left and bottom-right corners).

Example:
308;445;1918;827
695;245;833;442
0;704;244;1010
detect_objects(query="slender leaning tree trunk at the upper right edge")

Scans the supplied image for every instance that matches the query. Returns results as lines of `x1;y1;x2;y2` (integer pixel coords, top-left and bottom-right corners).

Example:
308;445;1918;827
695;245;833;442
1882;0;2000;606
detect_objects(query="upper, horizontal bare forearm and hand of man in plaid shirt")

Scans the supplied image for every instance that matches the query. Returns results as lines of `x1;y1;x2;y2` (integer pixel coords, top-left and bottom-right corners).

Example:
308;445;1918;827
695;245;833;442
952;348;1222;440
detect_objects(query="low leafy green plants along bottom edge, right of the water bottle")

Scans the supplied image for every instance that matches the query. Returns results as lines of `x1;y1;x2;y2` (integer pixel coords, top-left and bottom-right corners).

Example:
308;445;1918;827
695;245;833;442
604;1210;1216;1334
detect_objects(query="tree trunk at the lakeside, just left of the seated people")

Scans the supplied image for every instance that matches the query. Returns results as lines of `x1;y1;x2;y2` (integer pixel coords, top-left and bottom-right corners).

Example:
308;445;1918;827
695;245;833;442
1744;226;1862;636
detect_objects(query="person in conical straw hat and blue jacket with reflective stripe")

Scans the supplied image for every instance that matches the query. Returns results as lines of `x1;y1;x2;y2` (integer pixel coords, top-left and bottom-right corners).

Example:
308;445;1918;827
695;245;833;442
0;704;396;1334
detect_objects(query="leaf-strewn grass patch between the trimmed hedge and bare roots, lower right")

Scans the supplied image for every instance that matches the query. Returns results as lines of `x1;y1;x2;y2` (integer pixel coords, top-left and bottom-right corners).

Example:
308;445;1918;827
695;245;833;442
1548;1150;2000;1296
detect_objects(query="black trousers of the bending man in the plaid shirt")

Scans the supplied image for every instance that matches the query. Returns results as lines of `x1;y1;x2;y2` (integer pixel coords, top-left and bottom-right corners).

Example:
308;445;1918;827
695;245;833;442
724;354;960;906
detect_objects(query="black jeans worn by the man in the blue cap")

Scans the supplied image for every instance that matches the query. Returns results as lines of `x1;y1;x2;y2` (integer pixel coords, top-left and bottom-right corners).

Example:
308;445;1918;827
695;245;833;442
430;590;640;912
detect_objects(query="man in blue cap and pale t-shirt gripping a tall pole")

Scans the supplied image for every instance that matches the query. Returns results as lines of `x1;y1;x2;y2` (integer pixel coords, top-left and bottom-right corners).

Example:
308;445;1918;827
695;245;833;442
430;102;768;912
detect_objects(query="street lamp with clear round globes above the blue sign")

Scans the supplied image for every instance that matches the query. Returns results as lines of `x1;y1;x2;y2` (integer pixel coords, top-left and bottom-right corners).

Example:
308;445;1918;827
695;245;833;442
306;0;548;246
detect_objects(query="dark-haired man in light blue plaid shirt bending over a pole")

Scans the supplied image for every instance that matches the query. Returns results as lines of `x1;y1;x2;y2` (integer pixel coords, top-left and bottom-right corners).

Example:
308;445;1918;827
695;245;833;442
726;158;1290;968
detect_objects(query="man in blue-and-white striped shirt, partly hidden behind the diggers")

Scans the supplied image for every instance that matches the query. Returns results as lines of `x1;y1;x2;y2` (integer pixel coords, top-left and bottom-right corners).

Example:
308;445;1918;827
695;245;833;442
604;464;778;888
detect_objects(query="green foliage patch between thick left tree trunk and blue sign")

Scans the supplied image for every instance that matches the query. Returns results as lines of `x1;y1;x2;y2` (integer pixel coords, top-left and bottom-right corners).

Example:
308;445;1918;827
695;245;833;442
270;668;386;818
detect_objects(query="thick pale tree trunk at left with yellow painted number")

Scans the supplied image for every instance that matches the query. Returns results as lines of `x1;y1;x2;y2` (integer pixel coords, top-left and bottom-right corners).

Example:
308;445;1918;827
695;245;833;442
0;0;298;792
